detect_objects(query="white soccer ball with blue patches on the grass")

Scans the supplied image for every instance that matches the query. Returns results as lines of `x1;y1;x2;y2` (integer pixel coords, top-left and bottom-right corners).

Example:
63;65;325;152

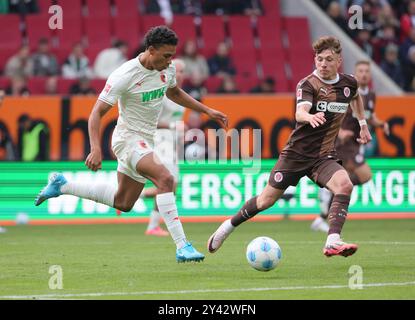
246;237;281;271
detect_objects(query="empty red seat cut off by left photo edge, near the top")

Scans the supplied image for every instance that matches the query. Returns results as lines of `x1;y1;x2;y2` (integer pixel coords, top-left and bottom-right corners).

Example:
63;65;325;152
0;14;22;50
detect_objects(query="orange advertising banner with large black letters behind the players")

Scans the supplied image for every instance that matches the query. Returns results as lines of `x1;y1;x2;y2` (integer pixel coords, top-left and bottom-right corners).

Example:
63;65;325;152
0;95;415;161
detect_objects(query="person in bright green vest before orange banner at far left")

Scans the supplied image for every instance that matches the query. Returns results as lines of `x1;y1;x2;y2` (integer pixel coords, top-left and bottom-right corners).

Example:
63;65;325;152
18;114;50;161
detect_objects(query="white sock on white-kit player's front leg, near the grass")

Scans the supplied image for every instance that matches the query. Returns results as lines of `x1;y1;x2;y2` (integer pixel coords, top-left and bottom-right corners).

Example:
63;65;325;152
156;192;187;249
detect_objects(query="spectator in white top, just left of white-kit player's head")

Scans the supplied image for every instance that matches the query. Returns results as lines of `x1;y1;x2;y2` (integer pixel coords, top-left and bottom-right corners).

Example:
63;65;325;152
94;41;128;79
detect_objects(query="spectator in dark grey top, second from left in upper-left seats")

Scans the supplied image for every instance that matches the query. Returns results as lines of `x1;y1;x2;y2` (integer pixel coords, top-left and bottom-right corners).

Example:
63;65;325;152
32;38;59;77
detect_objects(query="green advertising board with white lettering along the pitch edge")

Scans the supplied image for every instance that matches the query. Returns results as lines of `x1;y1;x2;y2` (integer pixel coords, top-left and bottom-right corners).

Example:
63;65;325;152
0;158;415;225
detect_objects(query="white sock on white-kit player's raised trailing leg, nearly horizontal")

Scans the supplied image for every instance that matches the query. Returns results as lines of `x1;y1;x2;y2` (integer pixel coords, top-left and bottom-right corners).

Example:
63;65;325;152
61;181;117;207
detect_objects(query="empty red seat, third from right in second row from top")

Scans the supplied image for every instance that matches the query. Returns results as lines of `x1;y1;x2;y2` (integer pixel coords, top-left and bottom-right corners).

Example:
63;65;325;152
229;16;255;50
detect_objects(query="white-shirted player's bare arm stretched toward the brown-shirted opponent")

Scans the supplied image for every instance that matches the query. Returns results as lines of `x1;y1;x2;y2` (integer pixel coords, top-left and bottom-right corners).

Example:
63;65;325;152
166;87;228;127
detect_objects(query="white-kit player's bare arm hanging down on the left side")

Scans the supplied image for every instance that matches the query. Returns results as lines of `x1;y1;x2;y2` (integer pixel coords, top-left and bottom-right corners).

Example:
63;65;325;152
85;100;112;171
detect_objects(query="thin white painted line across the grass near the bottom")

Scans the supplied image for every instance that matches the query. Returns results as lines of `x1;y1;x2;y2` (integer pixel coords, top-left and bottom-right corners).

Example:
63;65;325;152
0;281;415;299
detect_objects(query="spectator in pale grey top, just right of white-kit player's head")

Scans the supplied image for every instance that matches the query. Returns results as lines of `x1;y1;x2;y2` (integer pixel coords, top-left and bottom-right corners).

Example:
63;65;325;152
180;40;209;82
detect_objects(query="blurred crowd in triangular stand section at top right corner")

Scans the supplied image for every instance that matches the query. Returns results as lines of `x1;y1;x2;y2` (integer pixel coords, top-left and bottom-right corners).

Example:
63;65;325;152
315;0;415;92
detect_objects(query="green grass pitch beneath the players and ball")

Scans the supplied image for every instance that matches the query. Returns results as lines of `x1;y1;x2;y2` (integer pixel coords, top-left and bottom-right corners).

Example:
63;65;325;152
0;220;415;300
